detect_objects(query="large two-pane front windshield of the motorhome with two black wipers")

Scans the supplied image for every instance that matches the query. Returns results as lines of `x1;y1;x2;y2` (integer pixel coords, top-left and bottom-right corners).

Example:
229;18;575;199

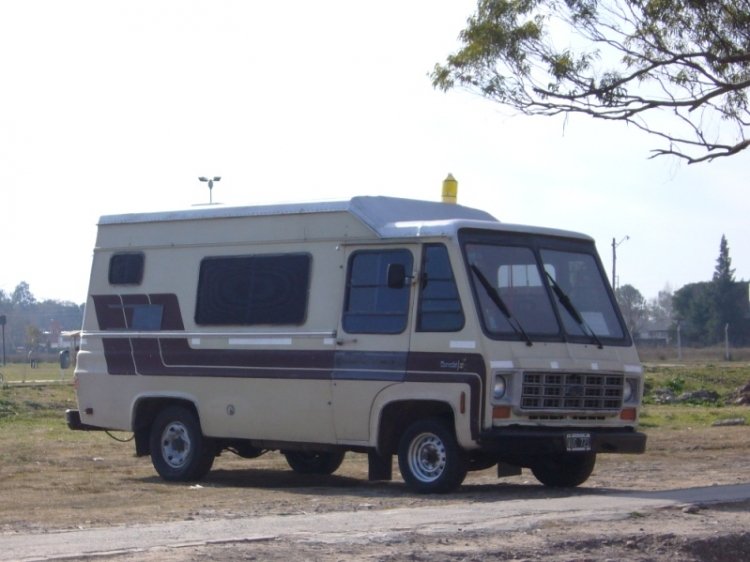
463;233;626;345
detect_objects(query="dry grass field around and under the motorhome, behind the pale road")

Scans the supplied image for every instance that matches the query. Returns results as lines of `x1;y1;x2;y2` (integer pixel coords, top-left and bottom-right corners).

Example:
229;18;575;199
0;356;750;560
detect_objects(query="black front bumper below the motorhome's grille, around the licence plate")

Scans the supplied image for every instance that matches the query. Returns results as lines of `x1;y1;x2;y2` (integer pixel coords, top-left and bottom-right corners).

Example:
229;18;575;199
479;427;646;457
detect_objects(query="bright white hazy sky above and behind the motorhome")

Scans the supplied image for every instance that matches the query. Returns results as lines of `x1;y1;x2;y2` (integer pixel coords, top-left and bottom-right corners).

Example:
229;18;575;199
0;0;750;303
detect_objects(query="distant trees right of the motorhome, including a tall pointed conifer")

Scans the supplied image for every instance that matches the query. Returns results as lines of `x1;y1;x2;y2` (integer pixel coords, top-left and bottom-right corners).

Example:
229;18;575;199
615;236;750;347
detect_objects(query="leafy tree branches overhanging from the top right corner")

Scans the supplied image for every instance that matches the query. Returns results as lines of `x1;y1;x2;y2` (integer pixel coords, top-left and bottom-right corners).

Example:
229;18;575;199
431;0;750;163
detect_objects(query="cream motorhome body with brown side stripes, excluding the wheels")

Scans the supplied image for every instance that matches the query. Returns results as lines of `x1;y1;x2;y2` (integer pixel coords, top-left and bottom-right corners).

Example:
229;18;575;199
70;197;645;490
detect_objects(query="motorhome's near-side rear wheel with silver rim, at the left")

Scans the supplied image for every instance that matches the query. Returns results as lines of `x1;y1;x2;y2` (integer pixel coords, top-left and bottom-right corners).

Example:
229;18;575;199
150;406;216;482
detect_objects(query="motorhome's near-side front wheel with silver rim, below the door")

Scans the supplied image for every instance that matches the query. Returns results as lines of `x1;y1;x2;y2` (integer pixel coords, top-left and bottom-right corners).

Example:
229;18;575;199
398;419;468;494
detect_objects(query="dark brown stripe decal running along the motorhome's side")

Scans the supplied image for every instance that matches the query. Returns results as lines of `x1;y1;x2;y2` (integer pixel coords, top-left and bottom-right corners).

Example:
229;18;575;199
92;294;486;438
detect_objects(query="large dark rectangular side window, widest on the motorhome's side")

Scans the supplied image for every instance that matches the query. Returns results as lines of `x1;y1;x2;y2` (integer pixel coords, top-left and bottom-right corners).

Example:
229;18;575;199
195;254;311;326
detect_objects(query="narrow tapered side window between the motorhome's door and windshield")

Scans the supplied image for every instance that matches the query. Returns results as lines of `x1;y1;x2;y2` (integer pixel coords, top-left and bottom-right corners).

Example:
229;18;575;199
417;244;464;332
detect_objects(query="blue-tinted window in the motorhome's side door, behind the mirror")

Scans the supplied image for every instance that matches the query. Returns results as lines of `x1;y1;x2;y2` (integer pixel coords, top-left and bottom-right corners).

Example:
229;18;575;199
342;249;414;334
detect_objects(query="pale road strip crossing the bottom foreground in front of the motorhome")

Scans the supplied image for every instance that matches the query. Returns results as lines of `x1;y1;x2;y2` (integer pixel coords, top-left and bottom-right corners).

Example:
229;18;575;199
0;484;750;561
